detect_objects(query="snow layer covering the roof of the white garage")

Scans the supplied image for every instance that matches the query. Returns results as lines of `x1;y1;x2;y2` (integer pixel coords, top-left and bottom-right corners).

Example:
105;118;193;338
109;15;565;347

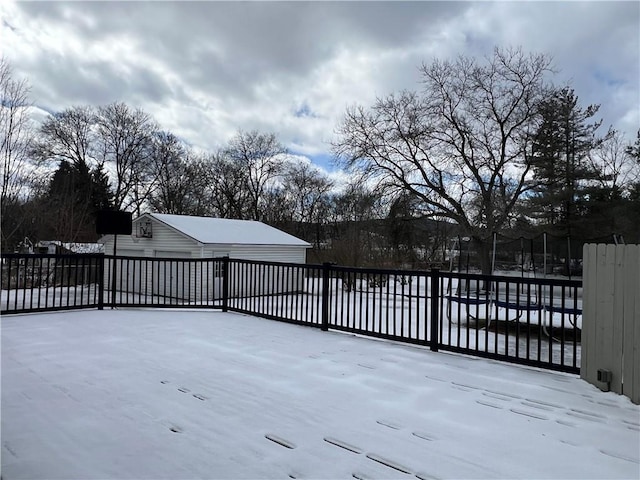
145;213;311;247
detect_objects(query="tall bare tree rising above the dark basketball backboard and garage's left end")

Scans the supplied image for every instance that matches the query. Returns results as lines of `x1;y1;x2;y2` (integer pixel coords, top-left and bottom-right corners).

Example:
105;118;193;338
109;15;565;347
96;103;158;214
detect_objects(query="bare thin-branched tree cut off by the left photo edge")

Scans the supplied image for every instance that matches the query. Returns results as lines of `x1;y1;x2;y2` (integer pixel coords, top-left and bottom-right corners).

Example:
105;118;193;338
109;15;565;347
0;57;33;245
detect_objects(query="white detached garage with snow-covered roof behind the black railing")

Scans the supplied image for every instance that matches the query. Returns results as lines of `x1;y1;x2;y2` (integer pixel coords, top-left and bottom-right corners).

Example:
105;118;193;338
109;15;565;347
99;213;311;299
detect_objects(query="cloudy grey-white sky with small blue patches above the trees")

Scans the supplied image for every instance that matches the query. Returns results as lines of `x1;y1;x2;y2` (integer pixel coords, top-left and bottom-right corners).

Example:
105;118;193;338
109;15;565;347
0;0;640;170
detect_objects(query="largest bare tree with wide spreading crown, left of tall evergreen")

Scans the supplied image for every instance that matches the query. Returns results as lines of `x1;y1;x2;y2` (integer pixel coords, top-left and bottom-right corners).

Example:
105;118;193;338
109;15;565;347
334;48;550;272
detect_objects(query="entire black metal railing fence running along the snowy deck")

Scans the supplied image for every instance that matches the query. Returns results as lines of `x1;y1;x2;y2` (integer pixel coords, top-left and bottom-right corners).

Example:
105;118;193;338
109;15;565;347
1;254;582;373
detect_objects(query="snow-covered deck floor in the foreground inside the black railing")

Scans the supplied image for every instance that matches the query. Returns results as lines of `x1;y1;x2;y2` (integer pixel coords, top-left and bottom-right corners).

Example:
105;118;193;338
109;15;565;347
1;309;640;480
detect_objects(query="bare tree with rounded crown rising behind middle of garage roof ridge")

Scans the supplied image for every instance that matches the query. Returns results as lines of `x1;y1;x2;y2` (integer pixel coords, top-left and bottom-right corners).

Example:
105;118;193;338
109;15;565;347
225;130;286;220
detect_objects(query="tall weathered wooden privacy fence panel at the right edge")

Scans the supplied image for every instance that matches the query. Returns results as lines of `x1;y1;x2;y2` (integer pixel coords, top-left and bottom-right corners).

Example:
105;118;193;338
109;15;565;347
580;244;640;404
